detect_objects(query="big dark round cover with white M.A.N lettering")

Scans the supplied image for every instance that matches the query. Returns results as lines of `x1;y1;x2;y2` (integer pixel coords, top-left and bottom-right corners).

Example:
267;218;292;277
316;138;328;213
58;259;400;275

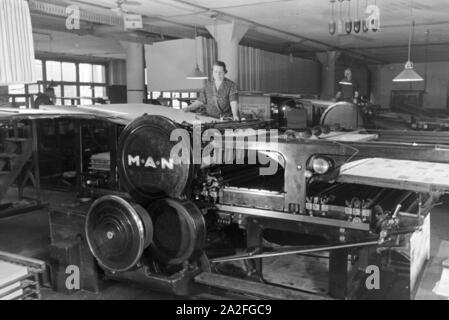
118;115;193;205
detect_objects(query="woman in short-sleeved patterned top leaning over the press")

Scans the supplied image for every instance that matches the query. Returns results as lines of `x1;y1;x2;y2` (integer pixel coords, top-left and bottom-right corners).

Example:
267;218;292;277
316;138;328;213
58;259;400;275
182;61;240;121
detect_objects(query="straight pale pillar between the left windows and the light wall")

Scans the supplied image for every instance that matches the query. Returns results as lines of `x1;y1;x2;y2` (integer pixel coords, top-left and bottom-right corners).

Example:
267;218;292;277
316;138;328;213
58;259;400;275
124;42;145;103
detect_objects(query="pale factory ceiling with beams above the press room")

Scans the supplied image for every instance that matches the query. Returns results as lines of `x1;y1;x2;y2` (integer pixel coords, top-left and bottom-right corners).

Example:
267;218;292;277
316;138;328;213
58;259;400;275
30;0;449;63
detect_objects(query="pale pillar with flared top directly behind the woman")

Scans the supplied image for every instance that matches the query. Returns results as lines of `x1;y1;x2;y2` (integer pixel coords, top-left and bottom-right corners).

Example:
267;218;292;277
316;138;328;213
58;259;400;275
206;21;248;83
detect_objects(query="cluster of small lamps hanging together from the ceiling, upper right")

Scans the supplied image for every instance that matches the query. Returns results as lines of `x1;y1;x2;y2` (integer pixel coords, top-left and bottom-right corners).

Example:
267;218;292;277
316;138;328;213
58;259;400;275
329;0;380;35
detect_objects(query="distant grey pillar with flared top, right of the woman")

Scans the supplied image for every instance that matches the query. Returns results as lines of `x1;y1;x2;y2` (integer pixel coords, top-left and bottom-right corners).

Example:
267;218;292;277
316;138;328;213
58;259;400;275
316;51;340;100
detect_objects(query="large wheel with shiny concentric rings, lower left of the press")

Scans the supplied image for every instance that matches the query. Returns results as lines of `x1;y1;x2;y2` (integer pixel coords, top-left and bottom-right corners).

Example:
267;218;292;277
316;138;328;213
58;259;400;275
86;195;153;272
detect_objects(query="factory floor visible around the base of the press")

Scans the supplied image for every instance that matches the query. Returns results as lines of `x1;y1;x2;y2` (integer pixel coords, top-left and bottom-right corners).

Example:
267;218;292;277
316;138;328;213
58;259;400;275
0;189;449;300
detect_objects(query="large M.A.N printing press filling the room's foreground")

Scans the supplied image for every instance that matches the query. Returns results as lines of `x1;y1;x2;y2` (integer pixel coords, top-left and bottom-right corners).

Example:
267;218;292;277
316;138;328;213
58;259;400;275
0;105;449;299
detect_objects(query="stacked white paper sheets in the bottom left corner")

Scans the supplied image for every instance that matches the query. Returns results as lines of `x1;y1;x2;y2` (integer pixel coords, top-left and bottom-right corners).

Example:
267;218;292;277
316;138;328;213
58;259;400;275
0;261;28;300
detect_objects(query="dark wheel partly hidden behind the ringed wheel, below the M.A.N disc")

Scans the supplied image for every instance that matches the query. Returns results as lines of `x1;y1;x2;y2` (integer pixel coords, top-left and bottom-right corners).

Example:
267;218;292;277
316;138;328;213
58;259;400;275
148;198;206;265
